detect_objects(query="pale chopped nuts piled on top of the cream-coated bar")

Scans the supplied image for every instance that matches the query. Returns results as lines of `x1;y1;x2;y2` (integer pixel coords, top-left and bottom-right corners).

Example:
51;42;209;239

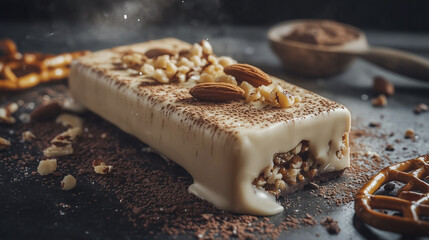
122;40;301;108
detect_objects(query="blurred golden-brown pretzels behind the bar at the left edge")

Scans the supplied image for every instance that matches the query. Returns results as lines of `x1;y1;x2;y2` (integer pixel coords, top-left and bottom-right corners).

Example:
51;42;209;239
0;39;88;91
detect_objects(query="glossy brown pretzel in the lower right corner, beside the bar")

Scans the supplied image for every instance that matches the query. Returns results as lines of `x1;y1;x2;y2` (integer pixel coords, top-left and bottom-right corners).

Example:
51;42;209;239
355;154;429;235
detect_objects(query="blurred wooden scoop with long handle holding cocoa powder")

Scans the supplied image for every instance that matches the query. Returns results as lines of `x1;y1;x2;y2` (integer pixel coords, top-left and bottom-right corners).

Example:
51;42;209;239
268;19;429;81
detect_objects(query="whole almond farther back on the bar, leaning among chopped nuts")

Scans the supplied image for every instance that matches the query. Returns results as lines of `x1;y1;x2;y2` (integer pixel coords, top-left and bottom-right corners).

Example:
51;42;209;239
223;63;272;87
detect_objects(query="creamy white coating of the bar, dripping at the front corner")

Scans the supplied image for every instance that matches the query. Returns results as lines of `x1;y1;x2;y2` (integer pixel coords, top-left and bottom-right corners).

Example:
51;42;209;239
69;38;350;215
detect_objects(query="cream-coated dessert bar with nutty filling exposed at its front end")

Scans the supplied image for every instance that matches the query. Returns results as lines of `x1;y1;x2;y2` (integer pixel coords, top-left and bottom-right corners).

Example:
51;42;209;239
69;38;351;215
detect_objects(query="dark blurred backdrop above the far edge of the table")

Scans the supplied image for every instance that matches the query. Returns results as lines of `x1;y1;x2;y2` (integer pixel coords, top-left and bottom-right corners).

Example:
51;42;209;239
0;0;429;32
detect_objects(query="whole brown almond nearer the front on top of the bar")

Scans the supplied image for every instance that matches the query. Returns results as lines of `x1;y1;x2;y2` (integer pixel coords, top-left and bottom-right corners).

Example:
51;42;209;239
189;82;244;102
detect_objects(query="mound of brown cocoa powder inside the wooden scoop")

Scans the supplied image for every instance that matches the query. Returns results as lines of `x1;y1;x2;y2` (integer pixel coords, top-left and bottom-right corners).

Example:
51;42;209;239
283;21;359;46
